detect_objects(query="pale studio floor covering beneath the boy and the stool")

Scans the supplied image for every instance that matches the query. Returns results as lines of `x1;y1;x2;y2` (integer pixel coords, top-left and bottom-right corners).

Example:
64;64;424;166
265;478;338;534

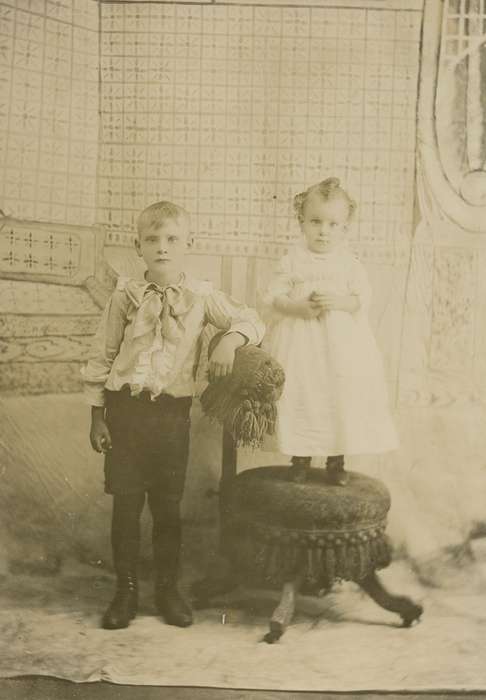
0;562;486;700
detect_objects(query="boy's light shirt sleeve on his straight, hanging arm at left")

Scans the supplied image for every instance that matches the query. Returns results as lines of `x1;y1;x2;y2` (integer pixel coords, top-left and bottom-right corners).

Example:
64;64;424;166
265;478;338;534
82;289;129;406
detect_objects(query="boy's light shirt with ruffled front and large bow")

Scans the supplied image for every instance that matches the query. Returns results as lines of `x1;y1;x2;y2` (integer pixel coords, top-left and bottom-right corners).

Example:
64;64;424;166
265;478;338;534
83;278;265;406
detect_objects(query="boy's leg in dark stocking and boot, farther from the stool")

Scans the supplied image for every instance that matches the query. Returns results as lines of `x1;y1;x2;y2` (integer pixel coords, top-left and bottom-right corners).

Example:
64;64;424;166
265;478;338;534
102;493;145;630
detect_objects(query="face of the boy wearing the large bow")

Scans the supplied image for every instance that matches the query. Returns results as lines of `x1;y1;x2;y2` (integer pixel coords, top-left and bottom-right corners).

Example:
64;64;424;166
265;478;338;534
135;218;192;275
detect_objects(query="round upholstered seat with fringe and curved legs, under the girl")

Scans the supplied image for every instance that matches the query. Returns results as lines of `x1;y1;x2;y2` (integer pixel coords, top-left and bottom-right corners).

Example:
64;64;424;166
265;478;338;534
194;466;422;643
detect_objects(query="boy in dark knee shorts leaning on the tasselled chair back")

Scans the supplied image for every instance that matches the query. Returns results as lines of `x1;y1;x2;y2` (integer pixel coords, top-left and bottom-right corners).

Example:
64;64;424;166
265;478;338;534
83;202;264;629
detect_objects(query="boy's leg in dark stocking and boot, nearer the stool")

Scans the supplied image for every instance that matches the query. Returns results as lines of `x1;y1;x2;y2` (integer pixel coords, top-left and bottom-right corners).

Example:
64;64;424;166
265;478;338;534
148;492;192;627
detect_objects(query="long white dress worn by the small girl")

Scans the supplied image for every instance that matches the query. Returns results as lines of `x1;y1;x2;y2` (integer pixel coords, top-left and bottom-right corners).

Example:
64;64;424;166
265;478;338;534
263;245;398;456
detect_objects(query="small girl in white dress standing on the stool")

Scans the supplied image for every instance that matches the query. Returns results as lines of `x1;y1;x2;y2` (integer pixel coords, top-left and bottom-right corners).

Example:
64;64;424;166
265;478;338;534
264;178;398;485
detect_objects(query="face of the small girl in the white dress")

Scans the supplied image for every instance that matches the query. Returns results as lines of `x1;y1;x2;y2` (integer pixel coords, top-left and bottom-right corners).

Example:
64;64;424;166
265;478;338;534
300;194;349;253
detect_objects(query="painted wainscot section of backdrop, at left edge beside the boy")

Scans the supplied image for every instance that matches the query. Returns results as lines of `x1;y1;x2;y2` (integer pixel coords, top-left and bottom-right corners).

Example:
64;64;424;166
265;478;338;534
0;218;107;394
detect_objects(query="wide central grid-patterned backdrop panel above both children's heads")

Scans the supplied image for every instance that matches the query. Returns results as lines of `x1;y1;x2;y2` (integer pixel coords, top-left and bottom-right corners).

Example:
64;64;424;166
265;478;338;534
98;3;421;264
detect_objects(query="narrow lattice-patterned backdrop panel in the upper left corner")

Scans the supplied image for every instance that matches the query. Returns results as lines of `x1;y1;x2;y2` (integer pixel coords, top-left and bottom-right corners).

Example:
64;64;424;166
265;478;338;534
0;0;99;224
